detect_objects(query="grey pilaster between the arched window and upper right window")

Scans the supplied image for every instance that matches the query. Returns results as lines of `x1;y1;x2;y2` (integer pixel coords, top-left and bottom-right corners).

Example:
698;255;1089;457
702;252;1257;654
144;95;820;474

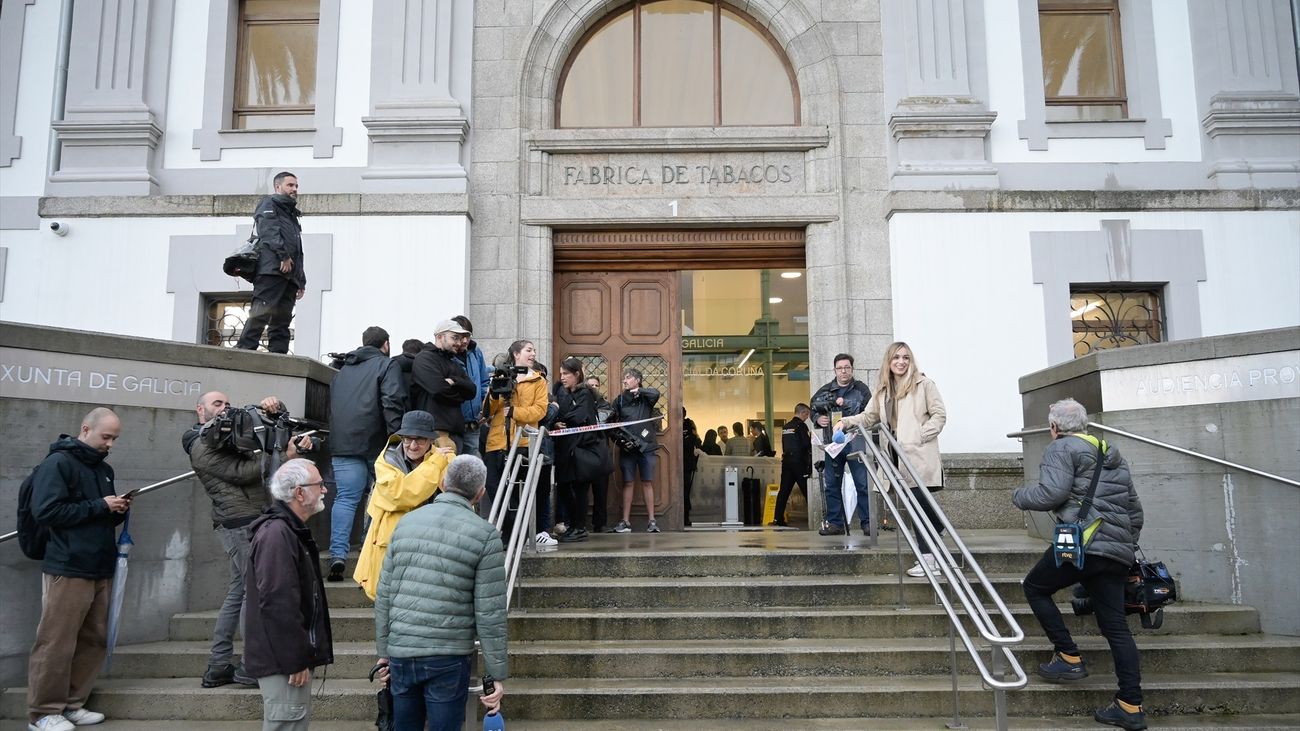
880;0;997;189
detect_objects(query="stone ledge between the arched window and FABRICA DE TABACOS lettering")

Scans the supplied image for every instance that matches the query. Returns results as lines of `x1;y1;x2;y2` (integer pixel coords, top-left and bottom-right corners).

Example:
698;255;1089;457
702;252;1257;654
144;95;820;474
527;126;831;153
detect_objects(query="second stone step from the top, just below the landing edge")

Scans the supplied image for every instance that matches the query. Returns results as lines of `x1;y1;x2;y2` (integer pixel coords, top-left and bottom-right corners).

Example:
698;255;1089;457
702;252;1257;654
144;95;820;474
515;574;1023;609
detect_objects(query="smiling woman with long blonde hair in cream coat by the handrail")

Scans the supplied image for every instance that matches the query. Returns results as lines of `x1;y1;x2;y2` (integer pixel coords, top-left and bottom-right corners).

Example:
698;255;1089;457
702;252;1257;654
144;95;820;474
836;342;948;576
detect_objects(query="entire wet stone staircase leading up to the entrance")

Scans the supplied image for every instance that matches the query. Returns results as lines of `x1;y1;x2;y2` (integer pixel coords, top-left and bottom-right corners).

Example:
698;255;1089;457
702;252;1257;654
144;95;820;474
0;531;1300;731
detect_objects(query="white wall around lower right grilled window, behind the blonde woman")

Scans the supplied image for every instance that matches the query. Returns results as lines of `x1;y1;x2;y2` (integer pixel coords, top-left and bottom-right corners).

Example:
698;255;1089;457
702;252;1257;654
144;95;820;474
889;212;1300;451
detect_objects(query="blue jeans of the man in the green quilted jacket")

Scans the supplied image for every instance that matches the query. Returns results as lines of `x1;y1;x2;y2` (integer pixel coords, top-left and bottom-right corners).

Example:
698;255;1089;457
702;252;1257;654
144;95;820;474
389;654;469;731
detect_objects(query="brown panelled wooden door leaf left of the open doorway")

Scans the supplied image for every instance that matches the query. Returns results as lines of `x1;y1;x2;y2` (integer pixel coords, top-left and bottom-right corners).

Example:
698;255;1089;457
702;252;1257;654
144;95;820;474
553;271;683;529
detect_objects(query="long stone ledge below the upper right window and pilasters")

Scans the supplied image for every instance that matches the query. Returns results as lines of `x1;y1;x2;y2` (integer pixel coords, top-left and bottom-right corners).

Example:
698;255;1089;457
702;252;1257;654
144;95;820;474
885;189;1300;216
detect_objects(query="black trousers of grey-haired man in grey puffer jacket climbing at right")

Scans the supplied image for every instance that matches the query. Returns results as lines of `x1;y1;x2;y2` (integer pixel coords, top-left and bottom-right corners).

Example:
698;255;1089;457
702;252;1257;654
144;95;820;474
1024;548;1141;705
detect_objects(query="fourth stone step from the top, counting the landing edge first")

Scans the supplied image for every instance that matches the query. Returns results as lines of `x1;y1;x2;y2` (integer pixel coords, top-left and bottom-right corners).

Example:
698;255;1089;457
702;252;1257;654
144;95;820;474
108;635;1300;684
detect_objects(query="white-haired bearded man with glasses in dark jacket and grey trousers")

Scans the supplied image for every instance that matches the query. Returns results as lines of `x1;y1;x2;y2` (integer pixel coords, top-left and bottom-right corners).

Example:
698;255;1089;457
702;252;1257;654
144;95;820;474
244;459;334;731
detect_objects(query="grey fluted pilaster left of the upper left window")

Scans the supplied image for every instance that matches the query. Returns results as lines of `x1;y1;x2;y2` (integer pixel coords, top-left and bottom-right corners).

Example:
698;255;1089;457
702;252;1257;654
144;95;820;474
49;0;174;195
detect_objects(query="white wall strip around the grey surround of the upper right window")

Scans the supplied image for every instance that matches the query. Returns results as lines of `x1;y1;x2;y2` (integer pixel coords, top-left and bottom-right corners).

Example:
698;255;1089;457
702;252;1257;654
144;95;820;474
984;0;1201;164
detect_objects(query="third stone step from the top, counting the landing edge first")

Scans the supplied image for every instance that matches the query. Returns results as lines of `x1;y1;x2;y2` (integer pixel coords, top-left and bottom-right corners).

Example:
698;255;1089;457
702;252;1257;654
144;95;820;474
170;602;1260;646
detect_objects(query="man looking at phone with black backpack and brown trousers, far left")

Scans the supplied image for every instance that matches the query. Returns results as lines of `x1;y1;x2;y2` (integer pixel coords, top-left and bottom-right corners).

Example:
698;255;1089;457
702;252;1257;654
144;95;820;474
27;407;131;731
